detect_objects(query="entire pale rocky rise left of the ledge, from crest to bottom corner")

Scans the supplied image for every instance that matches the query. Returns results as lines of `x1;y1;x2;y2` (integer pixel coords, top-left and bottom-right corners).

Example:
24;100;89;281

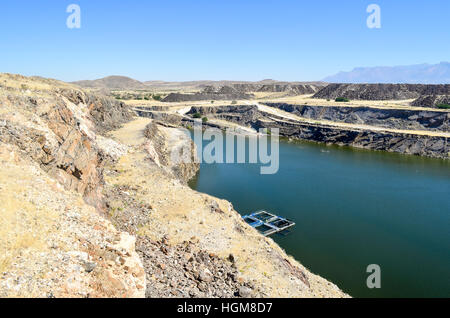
0;74;146;297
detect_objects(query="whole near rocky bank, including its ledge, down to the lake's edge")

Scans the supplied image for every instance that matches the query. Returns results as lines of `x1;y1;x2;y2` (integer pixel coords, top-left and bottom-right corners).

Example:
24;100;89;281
0;74;347;297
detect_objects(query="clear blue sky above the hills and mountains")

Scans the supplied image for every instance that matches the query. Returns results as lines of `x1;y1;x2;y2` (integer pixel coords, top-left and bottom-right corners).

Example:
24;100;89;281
0;0;450;81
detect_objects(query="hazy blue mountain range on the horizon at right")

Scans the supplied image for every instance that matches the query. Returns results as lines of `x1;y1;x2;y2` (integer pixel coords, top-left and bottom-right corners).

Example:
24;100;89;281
323;62;450;84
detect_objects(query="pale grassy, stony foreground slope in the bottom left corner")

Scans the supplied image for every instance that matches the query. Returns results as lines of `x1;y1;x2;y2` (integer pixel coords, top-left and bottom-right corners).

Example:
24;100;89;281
0;142;146;297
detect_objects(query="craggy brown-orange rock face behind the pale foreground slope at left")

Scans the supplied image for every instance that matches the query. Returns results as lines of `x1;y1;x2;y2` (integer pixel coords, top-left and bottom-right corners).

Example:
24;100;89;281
0;75;132;209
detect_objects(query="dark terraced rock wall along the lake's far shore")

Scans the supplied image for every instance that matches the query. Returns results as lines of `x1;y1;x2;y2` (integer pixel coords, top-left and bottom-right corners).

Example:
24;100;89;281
171;104;450;159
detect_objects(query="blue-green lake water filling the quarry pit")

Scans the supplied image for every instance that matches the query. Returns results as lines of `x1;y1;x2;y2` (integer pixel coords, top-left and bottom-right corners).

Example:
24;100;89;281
190;135;450;297
